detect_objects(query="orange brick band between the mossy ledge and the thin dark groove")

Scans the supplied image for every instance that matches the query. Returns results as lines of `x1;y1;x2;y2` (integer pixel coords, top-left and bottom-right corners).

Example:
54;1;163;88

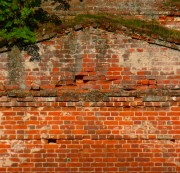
0;107;180;140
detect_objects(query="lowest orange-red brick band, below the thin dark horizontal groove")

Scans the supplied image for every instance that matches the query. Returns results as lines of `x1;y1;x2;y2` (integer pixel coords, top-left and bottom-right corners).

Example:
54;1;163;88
0;140;180;173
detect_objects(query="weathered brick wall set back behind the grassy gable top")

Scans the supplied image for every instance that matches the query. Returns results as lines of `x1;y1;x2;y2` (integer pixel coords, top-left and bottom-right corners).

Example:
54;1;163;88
42;0;180;30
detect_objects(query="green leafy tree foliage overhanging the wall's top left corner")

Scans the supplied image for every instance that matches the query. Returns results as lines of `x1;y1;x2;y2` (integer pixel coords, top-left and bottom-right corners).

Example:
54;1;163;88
0;0;69;47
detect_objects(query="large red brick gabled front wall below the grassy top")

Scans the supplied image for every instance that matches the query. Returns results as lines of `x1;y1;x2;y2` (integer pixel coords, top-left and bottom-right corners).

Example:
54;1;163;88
0;14;180;173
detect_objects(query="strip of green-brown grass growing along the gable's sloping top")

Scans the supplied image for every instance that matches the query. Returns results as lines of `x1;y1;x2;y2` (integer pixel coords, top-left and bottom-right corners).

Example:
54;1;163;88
71;14;180;43
